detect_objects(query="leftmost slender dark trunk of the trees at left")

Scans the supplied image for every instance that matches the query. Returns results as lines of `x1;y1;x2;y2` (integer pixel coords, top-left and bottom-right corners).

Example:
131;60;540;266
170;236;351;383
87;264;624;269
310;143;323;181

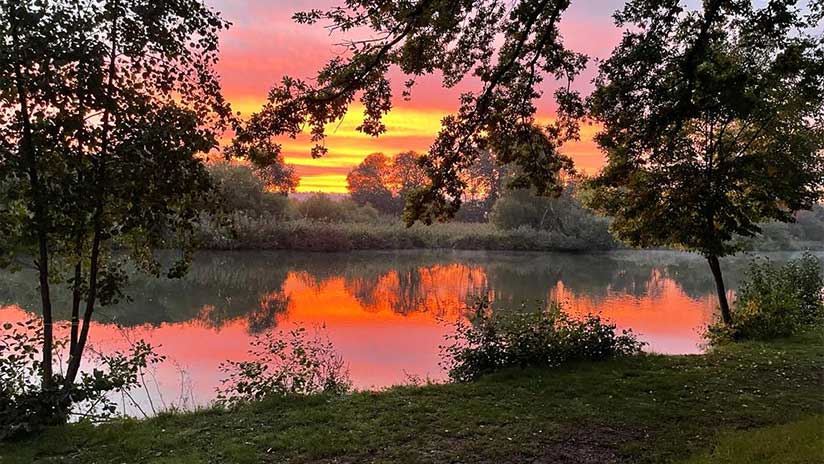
11;9;54;390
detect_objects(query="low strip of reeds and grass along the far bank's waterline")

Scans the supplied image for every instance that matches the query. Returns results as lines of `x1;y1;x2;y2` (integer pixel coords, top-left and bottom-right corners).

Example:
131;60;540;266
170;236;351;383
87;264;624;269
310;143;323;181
198;215;617;251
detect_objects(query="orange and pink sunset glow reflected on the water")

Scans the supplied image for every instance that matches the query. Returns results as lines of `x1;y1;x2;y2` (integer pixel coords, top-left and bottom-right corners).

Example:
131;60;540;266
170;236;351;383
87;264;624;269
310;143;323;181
0;263;713;404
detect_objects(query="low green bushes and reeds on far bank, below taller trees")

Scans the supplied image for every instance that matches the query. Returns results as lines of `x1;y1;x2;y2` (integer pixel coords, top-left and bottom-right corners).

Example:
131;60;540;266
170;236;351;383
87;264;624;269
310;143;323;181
195;161;824;251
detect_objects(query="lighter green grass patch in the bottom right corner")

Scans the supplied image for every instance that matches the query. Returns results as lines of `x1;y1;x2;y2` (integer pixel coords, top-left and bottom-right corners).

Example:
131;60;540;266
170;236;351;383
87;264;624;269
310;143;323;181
684;416;824;464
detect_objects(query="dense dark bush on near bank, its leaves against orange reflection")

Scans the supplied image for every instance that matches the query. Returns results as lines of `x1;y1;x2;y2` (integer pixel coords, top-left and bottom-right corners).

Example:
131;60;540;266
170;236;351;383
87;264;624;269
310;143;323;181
442;300;643;382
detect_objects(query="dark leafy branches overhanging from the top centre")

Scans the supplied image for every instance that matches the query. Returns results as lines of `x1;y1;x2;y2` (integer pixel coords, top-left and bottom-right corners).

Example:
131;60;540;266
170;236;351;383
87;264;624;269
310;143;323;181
234;0;586;223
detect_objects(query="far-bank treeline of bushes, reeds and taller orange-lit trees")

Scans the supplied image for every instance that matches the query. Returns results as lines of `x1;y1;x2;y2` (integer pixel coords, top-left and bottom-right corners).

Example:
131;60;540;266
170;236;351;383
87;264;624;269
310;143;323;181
197;160;618;251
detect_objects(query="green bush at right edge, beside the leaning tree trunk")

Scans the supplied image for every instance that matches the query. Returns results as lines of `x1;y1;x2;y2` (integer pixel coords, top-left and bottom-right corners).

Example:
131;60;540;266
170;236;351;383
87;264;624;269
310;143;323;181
707;253;824;343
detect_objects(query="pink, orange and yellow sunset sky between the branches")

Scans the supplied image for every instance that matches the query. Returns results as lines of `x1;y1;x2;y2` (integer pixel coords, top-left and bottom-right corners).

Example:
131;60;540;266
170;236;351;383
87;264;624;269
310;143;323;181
206;0;623;192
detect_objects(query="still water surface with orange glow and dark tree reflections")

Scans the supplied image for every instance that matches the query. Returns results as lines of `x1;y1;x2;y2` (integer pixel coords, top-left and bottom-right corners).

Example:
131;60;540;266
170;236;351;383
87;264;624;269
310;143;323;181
0;251;824;407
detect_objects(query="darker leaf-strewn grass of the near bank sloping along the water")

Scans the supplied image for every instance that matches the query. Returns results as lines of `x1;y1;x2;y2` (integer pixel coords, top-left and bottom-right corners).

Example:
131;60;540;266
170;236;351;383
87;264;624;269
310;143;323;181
0;331;824;464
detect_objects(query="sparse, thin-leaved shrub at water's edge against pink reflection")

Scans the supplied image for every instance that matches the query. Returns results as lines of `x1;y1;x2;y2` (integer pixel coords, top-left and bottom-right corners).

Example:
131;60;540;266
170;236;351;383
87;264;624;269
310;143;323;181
217;327;352;406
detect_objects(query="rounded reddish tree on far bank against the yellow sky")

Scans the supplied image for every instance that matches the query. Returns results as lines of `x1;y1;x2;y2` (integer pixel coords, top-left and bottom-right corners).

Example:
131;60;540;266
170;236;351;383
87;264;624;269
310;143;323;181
346;151;428;215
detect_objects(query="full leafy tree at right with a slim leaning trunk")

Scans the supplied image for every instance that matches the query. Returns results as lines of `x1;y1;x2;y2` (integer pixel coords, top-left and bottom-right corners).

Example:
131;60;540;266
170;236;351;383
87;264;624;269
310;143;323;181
589;0;824;323
